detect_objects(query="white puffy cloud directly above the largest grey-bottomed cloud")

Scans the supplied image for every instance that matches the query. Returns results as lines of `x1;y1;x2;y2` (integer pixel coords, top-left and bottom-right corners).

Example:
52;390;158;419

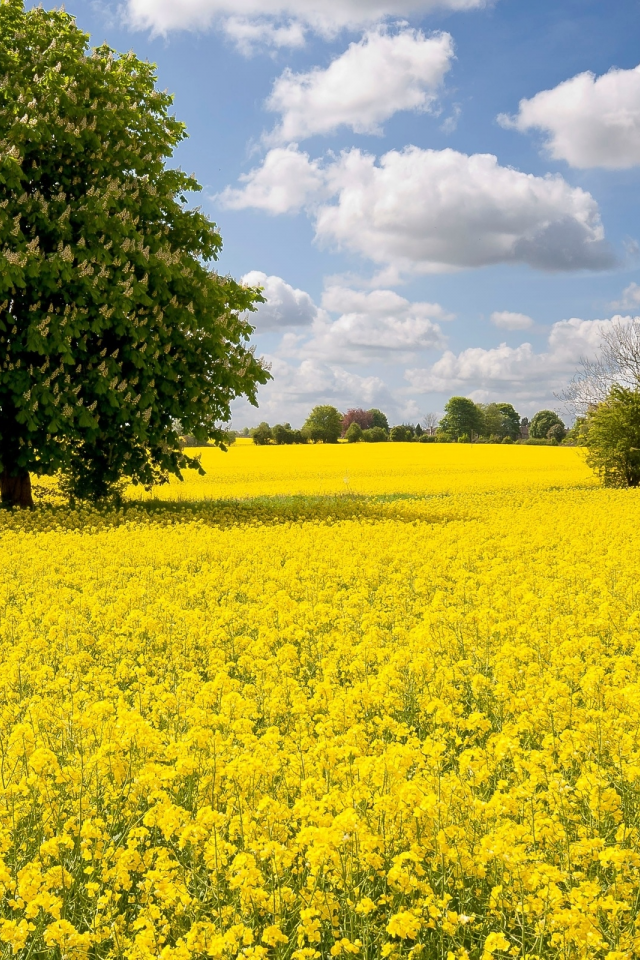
267;29;453;143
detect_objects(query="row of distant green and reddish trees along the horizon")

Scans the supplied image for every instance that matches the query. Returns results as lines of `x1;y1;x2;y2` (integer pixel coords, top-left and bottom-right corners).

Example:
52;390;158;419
236;397;573;446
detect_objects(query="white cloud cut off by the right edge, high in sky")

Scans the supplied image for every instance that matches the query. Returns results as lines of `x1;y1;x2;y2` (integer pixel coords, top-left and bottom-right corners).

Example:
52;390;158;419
498;66;640;170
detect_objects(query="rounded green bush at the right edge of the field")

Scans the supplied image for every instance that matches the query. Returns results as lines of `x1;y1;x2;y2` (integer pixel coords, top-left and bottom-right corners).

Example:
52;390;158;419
584;387;640;487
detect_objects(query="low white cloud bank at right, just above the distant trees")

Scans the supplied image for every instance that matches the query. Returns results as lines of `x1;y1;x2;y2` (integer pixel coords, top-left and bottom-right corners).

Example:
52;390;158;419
405;316;631;402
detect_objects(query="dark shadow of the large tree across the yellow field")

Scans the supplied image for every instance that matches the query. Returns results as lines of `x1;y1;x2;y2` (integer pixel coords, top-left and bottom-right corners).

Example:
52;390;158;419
0;494;475;534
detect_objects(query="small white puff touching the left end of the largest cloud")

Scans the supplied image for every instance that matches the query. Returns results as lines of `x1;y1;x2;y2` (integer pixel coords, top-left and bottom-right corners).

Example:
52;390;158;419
217;143;325;214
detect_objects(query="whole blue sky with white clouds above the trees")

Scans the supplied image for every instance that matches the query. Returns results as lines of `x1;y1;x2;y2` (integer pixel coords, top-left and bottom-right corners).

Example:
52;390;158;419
38;0;640;428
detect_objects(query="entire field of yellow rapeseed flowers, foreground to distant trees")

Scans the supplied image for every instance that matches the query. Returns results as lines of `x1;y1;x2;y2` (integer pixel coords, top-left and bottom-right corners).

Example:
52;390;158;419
0;444;640;960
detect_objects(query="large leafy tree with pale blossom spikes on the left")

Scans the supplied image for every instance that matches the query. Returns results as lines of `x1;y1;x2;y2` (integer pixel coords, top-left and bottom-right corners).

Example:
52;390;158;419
0;0;269;504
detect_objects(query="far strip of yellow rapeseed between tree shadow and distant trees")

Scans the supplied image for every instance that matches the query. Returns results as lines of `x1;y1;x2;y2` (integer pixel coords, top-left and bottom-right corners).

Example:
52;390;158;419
131;440;595;500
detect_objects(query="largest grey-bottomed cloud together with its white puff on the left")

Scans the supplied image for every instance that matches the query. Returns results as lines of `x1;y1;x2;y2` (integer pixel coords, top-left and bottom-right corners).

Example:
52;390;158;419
219;144;615;273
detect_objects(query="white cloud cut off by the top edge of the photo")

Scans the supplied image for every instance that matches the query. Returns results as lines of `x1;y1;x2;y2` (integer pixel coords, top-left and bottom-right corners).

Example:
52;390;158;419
125;0;487;35
